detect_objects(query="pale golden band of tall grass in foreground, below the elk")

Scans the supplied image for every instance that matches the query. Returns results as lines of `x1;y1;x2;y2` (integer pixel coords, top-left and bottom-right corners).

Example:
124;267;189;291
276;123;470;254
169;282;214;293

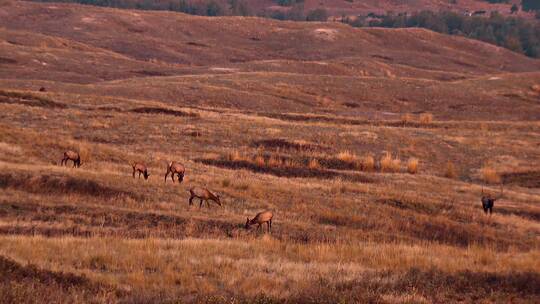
0;236;540;299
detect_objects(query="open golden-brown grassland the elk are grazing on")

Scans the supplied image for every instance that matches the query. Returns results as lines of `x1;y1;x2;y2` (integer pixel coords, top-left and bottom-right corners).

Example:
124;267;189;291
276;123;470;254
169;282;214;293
0;91;540;303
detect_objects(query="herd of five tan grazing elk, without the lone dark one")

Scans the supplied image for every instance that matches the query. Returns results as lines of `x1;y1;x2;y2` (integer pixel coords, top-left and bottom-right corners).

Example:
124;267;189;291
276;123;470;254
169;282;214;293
60;150;274;232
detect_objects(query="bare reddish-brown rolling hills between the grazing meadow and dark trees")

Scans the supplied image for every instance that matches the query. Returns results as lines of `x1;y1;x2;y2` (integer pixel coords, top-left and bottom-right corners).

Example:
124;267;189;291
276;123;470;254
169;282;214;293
0;2;540;119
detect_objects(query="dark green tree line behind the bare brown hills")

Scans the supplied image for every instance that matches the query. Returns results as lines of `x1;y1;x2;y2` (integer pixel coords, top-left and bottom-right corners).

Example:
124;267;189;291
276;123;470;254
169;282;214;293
35;0;540;58
